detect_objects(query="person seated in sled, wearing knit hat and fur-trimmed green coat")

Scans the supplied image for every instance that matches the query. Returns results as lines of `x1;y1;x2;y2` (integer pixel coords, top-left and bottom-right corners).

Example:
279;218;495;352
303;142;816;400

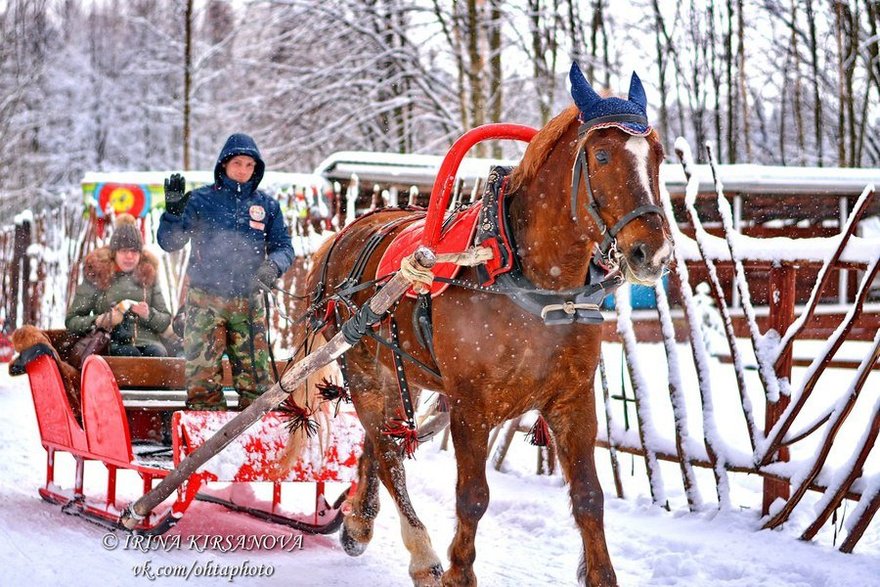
65;214;171;357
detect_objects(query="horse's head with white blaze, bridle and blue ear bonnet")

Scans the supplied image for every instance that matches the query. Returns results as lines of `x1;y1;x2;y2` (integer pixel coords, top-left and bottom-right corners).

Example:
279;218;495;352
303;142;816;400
569;63;672;284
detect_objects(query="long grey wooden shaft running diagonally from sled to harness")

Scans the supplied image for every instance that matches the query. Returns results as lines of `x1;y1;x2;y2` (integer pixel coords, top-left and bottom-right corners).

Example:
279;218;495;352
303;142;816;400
119;251;434;530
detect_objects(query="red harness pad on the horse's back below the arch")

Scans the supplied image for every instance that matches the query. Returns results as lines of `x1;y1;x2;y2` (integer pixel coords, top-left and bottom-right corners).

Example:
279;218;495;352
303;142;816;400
376;205;481;298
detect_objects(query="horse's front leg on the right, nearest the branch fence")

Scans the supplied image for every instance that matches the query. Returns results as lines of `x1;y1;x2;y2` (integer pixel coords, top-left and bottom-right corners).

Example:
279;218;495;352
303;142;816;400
544;404;617;587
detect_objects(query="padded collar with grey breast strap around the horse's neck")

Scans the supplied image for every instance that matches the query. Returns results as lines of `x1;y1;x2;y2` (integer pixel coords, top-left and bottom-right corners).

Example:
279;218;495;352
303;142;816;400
474;166;623;326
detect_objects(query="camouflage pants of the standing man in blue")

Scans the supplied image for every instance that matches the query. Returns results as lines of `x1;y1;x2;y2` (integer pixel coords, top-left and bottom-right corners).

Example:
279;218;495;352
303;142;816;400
184;289;270;410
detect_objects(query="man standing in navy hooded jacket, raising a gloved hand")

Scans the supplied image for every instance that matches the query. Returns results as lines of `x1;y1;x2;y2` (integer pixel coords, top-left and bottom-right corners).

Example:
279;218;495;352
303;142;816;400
157;134;293;410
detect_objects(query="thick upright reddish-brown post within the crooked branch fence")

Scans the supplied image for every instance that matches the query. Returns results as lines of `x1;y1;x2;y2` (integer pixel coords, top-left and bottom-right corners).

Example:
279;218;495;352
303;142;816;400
761;264;797;516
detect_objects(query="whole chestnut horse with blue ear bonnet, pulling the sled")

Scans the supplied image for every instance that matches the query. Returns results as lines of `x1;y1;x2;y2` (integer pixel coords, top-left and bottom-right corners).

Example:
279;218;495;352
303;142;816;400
308;66;672;585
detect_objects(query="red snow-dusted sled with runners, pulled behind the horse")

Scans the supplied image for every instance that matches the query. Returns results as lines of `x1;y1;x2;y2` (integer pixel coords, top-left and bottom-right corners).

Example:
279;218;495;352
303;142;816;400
13;347;363;534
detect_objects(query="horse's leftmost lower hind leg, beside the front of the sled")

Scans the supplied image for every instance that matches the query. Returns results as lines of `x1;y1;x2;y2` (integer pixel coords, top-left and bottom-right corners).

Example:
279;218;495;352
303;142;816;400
339;437;379;556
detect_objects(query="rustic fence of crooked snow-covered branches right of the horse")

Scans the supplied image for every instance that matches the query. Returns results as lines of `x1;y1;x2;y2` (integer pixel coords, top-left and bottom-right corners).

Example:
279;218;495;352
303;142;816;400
600;141;880;552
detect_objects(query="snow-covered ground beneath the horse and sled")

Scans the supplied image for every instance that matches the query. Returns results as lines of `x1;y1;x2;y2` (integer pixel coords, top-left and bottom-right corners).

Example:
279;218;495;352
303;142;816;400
0;346;880;587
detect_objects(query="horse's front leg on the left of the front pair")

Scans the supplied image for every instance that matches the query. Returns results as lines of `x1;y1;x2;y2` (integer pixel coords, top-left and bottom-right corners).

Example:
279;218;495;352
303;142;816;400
443;410;492;586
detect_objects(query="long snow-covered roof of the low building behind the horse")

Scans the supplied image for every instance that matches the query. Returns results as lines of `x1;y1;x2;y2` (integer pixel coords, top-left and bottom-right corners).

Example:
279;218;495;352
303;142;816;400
315;151;880;196
